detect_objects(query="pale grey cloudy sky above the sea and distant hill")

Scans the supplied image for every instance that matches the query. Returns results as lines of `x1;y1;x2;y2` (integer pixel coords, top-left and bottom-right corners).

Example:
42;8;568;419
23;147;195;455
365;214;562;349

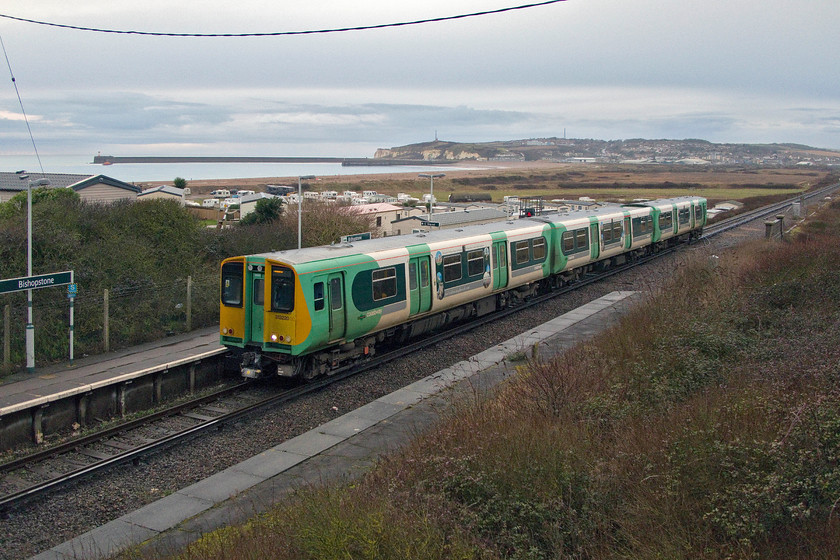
0;0;840;162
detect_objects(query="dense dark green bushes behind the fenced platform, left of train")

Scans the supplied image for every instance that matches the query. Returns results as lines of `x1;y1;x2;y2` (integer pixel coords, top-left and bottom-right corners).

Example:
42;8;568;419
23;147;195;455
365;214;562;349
0;189;370;372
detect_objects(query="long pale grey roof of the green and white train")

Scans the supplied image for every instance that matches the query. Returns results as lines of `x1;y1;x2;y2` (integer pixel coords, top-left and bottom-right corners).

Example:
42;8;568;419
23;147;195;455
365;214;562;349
251;196;700;265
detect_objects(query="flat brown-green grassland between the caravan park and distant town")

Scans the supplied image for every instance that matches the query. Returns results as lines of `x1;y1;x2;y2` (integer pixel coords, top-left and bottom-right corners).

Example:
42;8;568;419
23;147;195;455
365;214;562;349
146;161;827;206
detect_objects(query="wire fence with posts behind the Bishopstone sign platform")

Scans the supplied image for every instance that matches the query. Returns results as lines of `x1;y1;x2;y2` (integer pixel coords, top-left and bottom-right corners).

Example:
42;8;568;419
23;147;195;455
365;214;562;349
0;274;219;372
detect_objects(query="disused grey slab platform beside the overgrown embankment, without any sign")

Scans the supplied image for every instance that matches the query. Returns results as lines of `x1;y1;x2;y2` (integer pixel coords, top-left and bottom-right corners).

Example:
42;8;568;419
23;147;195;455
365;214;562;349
29;291;636;560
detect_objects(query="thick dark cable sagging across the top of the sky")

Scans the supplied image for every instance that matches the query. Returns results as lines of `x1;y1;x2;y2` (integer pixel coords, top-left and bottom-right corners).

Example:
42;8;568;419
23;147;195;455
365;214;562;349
0;0;566;37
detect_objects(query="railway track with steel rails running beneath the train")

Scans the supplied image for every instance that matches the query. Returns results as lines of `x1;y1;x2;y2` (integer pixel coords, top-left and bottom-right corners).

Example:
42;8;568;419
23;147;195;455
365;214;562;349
0;185;838;515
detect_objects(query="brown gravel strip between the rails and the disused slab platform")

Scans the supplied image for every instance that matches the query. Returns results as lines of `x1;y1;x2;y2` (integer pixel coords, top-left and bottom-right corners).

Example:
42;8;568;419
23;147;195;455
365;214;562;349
0;222;764;560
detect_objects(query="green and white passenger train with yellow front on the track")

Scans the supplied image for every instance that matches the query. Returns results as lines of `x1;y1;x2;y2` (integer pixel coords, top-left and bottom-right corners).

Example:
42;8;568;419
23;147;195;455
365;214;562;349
219;197;707;379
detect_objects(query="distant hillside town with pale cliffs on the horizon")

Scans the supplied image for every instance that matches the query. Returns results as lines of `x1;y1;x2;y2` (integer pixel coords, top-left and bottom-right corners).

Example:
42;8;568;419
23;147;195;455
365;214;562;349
374;138;840;167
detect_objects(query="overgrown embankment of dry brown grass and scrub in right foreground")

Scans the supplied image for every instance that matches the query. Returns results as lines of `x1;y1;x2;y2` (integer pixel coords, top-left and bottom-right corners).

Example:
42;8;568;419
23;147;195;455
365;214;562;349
130;199;840;559
